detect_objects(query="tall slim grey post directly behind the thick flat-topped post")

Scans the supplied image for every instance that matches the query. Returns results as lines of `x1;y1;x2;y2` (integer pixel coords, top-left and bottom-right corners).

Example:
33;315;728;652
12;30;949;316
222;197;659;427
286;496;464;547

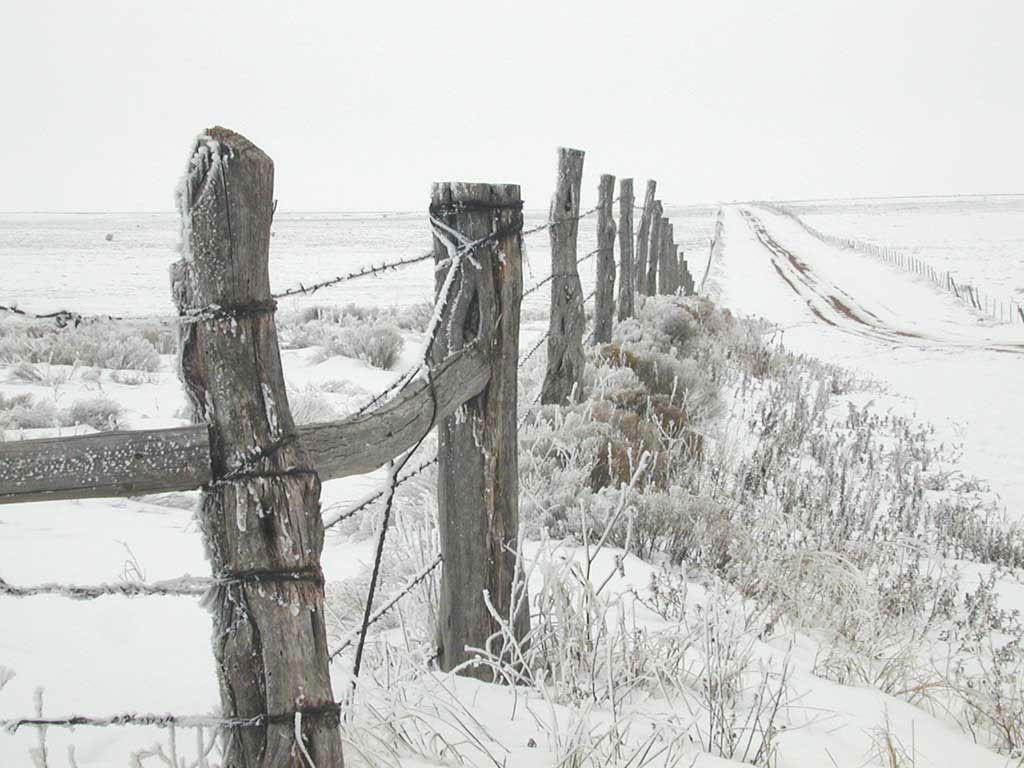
541;147;586;404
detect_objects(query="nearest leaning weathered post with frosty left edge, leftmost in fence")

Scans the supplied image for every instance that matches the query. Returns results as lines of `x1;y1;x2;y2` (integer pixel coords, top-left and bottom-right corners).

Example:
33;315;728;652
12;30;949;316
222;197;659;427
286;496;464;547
171;127;343;768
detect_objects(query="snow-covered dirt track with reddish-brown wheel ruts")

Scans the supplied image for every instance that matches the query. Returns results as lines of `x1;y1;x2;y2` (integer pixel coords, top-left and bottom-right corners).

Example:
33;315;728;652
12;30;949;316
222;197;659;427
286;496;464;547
713;206;1024;519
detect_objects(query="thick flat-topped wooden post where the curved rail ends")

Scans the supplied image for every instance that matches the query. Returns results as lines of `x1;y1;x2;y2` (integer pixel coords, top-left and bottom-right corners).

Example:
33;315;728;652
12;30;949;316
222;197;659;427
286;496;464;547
430;182;529;680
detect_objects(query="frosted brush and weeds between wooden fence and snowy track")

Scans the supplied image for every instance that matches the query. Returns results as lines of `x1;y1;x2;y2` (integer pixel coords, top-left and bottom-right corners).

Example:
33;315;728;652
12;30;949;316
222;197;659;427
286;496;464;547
512;299;1024;759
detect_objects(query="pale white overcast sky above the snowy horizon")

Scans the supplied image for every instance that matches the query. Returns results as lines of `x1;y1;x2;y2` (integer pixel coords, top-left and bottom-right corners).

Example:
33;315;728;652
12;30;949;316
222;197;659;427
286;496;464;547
0;0;1024;211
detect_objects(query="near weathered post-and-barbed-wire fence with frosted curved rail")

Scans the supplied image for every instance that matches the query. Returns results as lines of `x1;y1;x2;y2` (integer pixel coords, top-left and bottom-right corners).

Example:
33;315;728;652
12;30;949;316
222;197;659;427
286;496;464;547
0;128;700;768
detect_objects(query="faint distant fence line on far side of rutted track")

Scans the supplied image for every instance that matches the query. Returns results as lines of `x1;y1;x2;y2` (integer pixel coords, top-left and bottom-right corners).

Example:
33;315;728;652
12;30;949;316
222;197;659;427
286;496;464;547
758;203;1024;325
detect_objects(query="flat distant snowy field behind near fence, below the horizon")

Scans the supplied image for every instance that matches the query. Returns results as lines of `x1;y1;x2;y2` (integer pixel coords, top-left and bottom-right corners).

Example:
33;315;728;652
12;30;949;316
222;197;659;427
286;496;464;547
0;205;714;315
